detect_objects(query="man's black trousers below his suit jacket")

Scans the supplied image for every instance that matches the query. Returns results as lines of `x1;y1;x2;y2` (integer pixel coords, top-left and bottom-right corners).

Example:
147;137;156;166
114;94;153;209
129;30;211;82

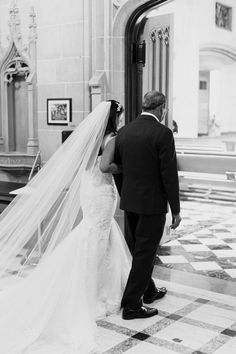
121;212;166;308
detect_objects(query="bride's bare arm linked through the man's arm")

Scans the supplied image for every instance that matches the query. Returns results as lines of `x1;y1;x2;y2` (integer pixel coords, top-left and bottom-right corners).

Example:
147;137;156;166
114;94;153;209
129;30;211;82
100;138;122;174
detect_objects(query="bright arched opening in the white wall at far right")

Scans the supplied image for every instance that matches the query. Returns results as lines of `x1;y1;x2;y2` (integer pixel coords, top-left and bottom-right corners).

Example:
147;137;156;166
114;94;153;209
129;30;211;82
198;43;236;136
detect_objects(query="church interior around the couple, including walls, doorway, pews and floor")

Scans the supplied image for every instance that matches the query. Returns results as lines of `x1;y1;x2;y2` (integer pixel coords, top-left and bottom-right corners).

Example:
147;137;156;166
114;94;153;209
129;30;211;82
0;0;236;354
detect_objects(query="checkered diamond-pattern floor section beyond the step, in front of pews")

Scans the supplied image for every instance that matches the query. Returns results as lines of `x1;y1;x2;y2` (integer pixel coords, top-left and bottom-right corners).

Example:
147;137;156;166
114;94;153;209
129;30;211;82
156;202;236;281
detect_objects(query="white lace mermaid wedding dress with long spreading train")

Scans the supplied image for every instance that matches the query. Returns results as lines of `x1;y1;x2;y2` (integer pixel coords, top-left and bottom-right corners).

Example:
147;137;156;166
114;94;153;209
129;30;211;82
0;157;130;354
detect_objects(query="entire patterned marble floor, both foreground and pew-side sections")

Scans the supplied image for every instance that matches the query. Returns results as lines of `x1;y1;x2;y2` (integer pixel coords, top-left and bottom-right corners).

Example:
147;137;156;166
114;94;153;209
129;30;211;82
94;201;236;354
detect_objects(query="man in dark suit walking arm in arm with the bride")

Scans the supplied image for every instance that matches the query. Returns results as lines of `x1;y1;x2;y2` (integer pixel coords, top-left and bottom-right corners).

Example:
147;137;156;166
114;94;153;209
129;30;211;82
115;91;181;320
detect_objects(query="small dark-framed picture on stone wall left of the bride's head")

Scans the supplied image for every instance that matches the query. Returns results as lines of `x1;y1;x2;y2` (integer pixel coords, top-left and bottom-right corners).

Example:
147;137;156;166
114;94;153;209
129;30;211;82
47;98;72;125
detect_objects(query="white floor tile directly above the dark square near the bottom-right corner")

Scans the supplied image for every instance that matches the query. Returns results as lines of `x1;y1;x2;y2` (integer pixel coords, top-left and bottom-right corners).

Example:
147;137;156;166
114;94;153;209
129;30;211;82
186;304;236;328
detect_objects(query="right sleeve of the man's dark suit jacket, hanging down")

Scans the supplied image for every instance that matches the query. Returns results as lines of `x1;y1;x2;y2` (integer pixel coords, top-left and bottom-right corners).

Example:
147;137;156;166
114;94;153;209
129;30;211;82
159;129;180;214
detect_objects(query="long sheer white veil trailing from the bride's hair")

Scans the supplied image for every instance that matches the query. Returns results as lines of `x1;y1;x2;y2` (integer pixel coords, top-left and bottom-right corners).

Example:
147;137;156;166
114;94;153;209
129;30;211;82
0;102;110;277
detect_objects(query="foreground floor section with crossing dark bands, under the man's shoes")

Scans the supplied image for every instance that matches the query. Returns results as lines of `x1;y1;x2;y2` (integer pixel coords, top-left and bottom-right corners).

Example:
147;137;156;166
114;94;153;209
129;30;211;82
98;281;236;354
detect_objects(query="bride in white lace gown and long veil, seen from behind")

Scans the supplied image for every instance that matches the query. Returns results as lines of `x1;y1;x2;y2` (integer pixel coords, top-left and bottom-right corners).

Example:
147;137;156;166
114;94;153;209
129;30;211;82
0;100;131;354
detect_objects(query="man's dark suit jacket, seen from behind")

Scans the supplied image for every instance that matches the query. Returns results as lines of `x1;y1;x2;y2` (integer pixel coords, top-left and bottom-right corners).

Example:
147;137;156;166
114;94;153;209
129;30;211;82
115;114;180;214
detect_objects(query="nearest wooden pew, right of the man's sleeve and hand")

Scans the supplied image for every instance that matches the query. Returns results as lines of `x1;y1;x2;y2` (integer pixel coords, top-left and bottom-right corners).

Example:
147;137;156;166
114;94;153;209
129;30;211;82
177;151;236;201
